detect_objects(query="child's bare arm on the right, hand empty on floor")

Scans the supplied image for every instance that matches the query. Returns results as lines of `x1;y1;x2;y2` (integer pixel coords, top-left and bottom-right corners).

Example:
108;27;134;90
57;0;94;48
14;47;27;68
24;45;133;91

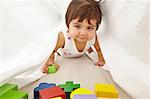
94;35;105;66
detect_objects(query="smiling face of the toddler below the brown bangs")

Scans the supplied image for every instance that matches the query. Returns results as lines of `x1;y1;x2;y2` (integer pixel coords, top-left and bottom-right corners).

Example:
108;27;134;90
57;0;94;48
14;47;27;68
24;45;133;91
69;18;96;42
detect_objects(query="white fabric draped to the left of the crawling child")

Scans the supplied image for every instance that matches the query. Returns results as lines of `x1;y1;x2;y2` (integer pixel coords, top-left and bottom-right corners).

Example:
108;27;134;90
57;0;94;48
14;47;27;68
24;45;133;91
0;1;61;85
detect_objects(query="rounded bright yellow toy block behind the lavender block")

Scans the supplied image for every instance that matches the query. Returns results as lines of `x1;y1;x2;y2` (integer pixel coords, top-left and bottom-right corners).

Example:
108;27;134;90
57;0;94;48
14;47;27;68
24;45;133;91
70;88;94;99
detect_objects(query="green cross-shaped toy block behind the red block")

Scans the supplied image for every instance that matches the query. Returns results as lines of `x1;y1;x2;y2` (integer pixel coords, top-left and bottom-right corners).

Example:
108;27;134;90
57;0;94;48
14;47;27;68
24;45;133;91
58;81;80;99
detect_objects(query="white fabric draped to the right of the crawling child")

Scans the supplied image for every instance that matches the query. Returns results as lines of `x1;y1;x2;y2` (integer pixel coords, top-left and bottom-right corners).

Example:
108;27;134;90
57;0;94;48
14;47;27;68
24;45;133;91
98;0;150;99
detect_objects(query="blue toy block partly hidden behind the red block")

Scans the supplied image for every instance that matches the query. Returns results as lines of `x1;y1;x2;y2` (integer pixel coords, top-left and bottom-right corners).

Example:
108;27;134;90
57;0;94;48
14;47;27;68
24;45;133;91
34;83;56;99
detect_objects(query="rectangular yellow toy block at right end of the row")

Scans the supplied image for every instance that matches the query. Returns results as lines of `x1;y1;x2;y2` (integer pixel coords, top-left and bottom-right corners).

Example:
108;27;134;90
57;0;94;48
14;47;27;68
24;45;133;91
95;84;119;98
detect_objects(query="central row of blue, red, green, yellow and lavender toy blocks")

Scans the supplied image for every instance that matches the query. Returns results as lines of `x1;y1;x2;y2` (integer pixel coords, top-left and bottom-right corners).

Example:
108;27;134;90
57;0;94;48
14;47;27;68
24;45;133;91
34;81;119;99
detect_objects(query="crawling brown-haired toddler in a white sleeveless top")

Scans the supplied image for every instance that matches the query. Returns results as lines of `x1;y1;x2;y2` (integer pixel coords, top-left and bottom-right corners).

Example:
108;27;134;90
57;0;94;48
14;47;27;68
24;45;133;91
42;0;105;73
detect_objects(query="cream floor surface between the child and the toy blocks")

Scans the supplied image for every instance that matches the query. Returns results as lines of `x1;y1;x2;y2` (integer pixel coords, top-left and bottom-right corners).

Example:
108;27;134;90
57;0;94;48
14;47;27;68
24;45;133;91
21;56;132;99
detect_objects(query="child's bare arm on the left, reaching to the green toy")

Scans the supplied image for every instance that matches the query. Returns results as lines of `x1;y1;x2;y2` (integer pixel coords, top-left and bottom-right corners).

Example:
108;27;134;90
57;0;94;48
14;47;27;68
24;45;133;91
42;32;65;73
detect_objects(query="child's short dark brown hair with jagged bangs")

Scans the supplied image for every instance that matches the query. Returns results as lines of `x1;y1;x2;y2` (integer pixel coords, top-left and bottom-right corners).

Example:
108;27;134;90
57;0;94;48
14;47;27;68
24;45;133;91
65;0;102;29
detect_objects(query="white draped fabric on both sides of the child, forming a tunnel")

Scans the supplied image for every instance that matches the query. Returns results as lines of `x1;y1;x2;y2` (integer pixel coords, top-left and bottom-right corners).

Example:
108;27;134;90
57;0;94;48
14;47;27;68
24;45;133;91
0;0;150;99
